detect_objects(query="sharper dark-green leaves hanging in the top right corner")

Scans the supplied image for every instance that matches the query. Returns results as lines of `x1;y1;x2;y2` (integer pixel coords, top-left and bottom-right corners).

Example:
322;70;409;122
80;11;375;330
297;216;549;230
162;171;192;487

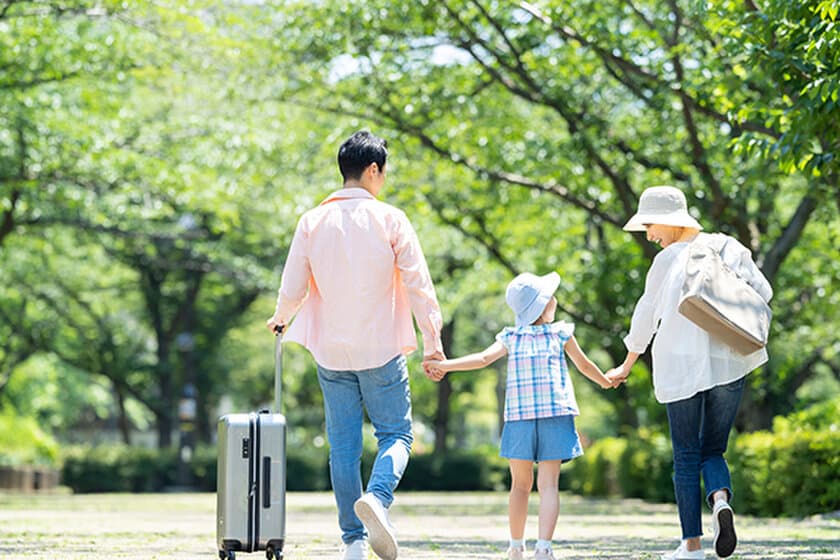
710;0;840;176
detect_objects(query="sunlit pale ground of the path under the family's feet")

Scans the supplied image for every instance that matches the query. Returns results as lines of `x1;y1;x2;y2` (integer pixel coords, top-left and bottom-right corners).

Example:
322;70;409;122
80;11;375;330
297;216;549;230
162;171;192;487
0;492;840;560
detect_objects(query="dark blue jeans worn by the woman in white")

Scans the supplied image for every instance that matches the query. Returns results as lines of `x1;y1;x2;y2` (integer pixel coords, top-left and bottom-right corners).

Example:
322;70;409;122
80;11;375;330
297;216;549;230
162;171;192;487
665;377;745;539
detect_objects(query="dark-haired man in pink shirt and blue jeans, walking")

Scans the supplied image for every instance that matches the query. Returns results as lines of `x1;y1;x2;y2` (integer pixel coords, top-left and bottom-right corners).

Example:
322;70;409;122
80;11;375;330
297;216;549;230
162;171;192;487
267;131;443;560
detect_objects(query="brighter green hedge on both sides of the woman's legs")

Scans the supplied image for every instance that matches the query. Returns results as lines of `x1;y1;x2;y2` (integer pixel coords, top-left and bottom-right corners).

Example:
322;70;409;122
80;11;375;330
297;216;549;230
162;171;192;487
564;399;840;517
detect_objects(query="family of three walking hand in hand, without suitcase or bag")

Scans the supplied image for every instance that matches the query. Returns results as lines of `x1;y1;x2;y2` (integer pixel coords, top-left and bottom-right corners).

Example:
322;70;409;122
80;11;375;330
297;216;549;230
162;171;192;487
267;131;772;560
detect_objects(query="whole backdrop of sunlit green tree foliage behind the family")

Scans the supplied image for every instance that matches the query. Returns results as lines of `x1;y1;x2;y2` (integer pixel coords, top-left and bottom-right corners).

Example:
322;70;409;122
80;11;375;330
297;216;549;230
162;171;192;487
0;0;840;512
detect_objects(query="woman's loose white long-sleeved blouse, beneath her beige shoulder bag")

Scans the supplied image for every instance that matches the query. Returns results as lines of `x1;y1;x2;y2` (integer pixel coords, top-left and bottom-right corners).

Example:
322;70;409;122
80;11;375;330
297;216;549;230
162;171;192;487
624;233;773;403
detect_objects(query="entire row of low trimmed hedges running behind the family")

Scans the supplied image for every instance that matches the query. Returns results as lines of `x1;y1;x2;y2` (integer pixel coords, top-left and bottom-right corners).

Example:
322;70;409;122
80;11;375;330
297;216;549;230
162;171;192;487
62;399;840;516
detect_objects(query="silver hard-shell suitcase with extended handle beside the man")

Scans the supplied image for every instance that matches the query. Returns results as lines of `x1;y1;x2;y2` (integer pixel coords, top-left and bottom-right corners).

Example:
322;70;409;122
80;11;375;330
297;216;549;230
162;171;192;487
216;331;286;560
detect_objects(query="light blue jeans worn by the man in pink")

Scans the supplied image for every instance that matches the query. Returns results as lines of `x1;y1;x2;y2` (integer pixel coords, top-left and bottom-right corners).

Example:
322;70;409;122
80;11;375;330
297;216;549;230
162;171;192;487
318;356;413;544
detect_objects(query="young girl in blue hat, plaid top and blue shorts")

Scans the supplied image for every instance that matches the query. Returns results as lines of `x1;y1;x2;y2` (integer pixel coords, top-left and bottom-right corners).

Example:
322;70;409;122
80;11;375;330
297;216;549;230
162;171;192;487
426;272;613;560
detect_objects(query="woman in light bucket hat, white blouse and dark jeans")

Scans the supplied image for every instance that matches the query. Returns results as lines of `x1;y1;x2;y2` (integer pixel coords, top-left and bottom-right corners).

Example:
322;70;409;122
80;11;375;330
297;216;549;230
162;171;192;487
608;187;773;560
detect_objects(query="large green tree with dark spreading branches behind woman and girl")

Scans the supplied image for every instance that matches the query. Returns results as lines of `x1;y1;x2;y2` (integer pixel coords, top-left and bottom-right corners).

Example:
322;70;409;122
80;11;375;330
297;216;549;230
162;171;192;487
258;0;838;427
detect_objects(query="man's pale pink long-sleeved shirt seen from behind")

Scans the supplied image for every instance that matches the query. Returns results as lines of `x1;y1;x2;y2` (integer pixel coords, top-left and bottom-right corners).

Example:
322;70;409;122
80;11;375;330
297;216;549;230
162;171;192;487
274;188;443;370
